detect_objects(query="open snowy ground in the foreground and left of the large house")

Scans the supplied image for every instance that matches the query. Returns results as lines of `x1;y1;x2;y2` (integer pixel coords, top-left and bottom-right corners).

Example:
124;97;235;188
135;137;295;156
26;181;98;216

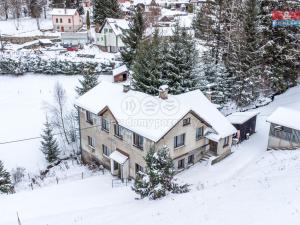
0;75;300;225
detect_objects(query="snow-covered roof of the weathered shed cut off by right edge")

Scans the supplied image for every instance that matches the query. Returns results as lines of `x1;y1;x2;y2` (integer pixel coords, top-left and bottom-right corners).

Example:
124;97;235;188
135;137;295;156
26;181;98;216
267;107;300;130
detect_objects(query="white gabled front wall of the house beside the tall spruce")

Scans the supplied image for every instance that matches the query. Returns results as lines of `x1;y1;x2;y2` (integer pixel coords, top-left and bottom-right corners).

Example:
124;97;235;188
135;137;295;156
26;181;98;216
96;22;125;52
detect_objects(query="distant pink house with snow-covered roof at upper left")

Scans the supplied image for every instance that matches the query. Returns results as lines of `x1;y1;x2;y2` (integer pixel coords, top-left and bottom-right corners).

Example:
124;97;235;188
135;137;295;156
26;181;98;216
50;8;83;32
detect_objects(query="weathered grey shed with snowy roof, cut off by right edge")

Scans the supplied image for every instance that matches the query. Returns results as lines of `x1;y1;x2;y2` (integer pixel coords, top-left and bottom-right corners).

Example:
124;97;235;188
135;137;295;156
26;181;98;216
267;107;300;150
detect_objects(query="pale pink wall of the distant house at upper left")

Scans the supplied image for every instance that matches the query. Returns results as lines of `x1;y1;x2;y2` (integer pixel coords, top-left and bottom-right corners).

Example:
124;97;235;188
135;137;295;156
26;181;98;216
52;12;83;32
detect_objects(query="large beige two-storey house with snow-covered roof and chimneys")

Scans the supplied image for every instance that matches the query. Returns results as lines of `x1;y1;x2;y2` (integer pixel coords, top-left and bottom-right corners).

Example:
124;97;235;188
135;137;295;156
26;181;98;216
75;82;236;178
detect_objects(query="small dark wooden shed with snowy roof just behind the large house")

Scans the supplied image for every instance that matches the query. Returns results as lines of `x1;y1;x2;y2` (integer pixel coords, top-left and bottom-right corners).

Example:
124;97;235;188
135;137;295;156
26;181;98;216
227;112;259;142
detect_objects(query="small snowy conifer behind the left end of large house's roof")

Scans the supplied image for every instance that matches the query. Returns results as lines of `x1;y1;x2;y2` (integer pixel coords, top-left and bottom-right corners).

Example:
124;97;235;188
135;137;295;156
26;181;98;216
75;68;98;96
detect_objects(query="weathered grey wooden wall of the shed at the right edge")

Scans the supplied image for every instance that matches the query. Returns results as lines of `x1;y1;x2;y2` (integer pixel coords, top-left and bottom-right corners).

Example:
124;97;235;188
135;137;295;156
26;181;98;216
268;123;300;149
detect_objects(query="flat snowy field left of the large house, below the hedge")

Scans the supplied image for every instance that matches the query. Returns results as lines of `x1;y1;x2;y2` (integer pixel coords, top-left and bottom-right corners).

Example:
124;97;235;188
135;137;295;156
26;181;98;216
0;74;112;172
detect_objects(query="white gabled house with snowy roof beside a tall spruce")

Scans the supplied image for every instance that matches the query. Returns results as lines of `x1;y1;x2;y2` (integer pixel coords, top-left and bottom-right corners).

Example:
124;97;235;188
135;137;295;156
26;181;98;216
96;18;129;52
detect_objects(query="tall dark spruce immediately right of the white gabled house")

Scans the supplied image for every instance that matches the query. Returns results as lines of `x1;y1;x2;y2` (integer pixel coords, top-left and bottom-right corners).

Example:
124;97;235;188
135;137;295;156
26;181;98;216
121;7;146;68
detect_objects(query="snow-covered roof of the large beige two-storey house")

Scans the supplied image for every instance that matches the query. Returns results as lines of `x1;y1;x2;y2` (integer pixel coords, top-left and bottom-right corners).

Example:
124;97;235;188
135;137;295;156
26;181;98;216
75;81;236;142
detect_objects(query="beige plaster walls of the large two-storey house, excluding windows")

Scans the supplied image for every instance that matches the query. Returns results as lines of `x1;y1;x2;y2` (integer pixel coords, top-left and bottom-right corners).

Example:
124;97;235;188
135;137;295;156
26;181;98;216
79;110;232;178
